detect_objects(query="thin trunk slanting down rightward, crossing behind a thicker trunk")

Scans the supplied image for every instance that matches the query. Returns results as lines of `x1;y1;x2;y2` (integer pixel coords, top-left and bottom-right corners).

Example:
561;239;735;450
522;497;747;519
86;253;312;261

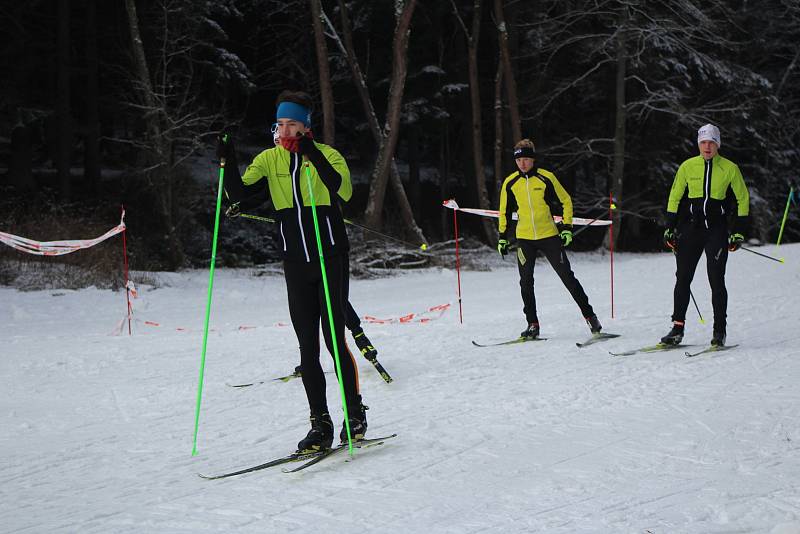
322;0;427;243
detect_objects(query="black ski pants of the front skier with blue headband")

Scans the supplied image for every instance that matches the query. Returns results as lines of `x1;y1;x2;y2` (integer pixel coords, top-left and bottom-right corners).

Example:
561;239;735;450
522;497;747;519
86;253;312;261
283;255;361;415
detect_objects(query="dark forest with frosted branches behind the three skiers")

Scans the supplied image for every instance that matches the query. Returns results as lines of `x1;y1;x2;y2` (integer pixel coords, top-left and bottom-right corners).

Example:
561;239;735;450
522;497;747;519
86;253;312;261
0;0;800;283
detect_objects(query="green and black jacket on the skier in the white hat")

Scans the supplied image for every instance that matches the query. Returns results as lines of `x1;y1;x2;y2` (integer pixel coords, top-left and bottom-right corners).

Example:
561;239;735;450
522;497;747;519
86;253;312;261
667;154;750;229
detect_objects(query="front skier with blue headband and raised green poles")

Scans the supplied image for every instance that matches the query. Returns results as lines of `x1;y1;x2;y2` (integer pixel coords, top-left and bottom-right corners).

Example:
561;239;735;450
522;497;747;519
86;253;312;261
219;91;367;452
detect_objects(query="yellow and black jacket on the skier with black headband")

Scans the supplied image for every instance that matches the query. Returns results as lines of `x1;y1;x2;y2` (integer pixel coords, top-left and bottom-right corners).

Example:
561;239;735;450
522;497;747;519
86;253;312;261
500;168;572;239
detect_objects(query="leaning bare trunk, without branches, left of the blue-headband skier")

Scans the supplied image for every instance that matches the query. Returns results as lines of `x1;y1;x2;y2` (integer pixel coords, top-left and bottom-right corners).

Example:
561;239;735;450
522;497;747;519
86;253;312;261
125;0;184;269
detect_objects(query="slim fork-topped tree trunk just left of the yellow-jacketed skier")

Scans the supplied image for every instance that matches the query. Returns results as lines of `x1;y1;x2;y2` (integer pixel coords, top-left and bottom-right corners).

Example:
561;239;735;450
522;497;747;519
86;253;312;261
450;0;497;243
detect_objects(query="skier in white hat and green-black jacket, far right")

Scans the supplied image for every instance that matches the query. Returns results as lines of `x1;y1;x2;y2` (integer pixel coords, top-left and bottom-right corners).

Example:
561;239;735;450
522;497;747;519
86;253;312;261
661;124;750;346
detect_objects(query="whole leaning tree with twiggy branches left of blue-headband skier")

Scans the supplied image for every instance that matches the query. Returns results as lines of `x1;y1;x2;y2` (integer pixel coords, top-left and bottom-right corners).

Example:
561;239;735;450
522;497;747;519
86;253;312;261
120;0;253;269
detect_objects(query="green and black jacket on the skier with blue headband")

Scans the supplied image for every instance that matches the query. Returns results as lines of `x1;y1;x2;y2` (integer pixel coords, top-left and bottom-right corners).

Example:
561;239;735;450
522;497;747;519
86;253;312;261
225;142;353;262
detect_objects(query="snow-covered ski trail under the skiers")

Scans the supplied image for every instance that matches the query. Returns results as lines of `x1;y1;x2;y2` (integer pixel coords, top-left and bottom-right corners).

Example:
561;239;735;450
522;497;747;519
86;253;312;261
0;245;800;534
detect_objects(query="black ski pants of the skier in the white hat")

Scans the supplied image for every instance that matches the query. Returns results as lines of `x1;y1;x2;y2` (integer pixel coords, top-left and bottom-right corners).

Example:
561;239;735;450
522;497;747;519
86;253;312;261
672;224;728;331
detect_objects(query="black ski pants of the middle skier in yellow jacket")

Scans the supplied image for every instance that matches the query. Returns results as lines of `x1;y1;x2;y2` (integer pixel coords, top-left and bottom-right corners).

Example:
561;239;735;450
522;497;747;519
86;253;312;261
517;240;594;323
